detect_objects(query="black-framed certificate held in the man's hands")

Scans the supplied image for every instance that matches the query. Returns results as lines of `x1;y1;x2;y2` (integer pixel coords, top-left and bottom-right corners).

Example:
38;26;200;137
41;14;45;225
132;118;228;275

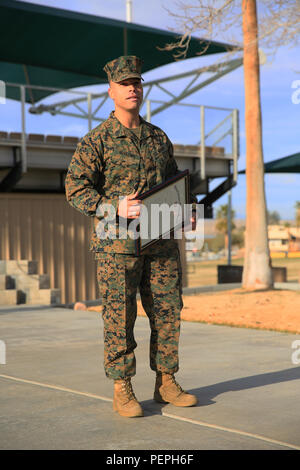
135;170;190;255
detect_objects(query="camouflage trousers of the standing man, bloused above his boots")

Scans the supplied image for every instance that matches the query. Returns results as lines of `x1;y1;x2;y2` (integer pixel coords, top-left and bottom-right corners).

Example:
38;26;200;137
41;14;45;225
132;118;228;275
97;248;183;380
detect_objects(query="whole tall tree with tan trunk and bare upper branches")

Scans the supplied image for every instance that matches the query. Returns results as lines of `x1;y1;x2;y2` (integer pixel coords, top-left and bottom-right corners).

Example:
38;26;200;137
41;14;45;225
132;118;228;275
165;0;300;289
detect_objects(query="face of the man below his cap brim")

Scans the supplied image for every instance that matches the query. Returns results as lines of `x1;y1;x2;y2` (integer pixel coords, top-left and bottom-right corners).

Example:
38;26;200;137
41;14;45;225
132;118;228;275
108;78;143;111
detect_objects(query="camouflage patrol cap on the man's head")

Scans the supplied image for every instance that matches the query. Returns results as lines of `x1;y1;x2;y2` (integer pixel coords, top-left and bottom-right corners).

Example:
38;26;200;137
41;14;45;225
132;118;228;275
103;55;143;83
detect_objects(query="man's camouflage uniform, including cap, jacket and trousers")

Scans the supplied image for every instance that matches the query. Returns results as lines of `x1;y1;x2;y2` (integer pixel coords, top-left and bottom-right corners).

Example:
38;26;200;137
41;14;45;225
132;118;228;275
65;56;197;414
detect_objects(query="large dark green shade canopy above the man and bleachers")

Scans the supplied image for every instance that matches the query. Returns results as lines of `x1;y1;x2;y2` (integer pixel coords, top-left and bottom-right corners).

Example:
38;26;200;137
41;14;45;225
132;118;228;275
0;0;235;102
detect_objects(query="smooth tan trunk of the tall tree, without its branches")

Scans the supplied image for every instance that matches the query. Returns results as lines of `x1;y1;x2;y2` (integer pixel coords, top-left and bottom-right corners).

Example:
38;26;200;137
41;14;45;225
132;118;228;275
242;0;273;289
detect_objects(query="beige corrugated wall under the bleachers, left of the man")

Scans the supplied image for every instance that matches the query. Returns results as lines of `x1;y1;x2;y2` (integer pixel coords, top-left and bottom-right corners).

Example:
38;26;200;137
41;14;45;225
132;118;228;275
0;193;99;303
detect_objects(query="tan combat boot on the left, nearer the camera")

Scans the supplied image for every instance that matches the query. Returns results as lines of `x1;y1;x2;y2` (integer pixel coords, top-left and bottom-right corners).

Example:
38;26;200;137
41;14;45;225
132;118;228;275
113;377;144;418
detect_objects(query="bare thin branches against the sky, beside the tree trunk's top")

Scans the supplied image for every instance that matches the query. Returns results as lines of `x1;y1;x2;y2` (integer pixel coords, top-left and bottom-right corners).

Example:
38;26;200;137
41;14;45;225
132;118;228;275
162;0;300;60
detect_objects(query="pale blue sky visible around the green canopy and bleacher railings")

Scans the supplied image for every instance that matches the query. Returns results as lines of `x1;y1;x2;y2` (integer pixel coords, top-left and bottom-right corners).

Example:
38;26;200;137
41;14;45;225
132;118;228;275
0;0;300;220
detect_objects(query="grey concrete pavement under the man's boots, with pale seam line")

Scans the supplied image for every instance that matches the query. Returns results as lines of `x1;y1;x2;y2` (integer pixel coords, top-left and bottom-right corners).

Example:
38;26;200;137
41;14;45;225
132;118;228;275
0;305;300;450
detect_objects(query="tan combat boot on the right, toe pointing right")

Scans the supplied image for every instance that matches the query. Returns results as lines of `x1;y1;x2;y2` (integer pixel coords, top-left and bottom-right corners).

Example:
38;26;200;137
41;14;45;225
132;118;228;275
153;374;198;406
